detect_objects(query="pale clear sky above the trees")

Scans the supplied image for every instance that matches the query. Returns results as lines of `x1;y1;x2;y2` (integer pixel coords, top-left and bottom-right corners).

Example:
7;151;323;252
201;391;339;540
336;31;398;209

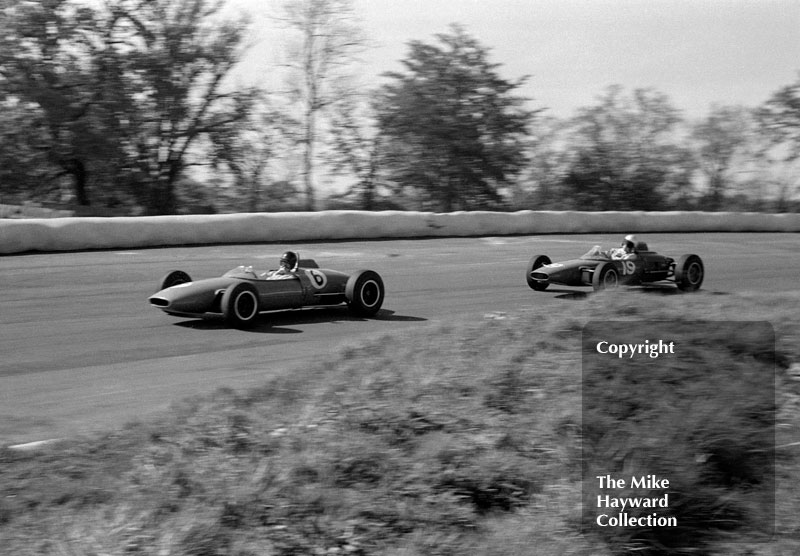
228;0;800;117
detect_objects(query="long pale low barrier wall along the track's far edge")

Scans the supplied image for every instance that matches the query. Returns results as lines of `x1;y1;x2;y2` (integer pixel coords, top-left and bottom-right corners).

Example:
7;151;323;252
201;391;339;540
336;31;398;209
0;211;800;254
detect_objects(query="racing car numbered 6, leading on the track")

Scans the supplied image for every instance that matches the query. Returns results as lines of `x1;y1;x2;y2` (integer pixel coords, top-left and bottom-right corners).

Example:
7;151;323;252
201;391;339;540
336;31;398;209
148;257;385;328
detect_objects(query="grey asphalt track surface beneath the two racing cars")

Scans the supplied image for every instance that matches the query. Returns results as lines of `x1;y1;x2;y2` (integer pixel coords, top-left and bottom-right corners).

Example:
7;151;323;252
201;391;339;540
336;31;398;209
0;234;800;446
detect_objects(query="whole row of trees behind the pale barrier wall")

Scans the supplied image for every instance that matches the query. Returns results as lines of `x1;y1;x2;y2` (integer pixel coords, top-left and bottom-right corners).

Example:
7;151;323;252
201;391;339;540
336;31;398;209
0;0;800;214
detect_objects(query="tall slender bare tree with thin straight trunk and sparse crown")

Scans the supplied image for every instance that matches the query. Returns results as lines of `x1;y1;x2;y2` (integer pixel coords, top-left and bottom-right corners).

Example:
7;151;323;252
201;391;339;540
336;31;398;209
280;0;366;210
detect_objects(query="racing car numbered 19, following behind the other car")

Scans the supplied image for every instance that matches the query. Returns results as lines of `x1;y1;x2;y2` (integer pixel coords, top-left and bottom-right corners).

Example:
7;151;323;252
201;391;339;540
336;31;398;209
525;242;705;292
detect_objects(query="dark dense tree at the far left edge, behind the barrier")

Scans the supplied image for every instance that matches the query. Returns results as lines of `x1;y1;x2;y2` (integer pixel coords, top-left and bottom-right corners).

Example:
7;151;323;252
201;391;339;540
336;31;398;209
0;0;120;206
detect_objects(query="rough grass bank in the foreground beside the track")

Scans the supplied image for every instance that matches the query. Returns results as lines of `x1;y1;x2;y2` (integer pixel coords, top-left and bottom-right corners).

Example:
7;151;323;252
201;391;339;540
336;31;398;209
0;293;800;556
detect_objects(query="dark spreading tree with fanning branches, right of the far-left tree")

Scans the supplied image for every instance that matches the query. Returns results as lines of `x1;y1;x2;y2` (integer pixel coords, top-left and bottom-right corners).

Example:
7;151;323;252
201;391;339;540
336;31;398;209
112;0;253;213
